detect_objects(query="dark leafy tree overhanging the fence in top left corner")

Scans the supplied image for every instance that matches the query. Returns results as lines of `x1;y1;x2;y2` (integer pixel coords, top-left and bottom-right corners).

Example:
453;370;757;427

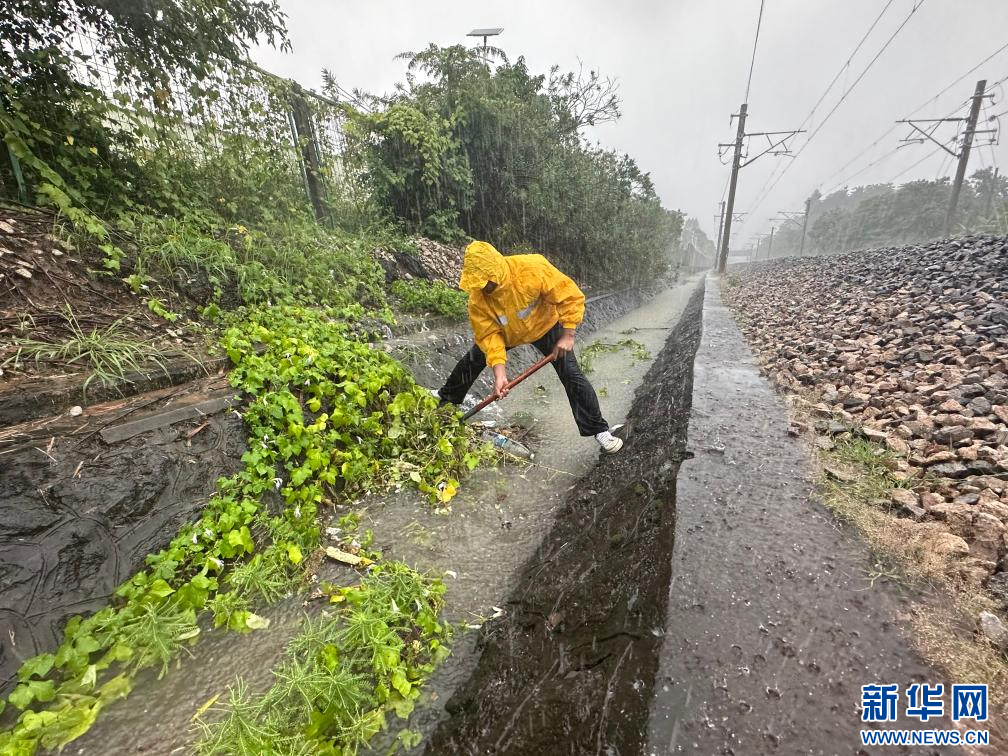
0;0;286;222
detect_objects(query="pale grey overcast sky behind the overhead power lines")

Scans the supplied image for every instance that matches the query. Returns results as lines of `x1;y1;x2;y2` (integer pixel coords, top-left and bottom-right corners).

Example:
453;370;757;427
254;0;1008;248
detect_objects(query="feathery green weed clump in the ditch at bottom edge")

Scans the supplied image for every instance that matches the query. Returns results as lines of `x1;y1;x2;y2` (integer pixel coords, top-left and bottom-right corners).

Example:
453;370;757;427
197;561;451;756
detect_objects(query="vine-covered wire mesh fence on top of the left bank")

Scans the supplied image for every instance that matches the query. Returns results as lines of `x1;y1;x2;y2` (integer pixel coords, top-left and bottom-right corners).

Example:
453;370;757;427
0;20;364;222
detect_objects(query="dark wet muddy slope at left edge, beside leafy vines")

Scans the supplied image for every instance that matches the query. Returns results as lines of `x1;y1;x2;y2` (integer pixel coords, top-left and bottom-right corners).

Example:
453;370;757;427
0;378;245;691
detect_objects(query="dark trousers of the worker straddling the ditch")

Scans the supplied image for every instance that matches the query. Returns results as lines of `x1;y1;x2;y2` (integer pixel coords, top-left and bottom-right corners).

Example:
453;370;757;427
437;323;609;435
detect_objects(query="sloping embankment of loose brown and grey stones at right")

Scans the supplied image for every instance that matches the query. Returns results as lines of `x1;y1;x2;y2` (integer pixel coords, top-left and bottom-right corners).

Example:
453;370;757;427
725;236;1008;608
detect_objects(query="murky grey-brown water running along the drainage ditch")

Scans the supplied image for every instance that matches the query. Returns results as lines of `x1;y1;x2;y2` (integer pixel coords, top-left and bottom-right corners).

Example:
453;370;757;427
72;278;698;754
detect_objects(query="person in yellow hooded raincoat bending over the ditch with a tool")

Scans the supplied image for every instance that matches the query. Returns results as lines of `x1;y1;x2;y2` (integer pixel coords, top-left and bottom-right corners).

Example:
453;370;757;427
435;241;623;454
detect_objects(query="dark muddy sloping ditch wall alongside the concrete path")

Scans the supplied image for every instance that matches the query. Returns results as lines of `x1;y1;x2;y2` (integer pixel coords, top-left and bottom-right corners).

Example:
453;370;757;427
426;287;703;756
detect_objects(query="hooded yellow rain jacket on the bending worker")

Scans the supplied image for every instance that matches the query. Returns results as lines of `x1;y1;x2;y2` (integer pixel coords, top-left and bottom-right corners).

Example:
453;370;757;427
459;237;585;367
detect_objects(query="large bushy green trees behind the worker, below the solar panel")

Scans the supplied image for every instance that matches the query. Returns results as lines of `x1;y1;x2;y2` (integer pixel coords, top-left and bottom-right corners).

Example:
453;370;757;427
340;45;682;283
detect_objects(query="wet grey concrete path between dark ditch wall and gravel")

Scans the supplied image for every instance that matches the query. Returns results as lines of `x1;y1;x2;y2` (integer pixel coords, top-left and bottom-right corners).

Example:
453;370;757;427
646;278;951;756
